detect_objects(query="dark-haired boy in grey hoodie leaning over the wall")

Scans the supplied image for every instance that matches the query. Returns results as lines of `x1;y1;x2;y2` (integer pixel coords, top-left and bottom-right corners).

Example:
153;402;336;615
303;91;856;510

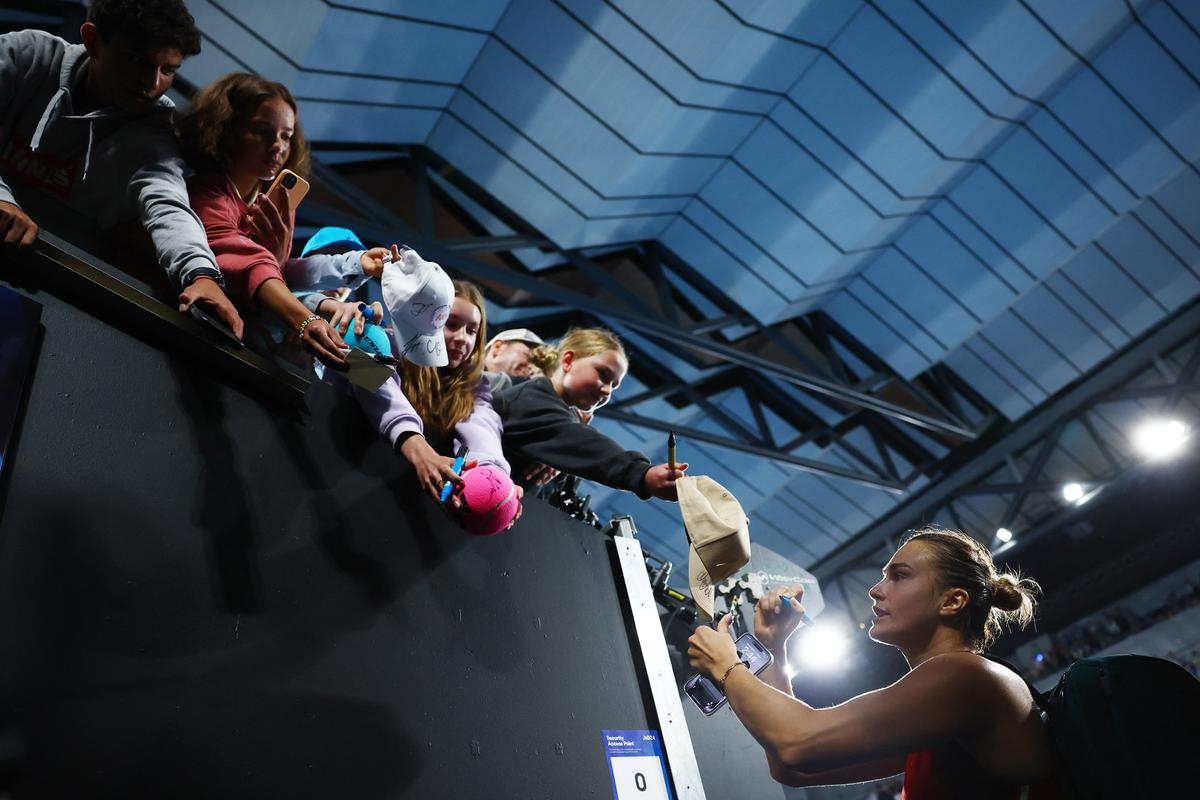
0;0;242;338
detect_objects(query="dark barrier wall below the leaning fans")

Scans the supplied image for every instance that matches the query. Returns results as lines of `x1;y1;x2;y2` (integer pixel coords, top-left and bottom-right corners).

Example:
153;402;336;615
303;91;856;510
0;282;667;799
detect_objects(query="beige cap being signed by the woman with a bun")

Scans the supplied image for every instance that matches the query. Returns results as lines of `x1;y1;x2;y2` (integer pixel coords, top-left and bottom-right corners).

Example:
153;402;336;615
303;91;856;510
676;475;750;619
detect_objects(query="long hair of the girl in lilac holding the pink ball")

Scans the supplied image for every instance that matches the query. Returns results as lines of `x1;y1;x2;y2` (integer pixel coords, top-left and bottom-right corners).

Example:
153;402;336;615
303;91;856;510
402;281;487;437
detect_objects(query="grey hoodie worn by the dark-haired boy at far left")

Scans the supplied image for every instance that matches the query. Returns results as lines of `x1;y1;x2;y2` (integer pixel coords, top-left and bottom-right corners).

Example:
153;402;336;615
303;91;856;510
0;30;221;285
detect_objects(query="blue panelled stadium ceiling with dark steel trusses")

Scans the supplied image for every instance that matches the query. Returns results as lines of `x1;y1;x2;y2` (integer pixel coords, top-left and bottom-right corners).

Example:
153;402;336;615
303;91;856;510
21;0;1200;614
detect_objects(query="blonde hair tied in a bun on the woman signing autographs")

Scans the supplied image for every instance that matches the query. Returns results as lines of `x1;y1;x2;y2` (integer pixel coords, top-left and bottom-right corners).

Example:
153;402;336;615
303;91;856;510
905;527;1042;652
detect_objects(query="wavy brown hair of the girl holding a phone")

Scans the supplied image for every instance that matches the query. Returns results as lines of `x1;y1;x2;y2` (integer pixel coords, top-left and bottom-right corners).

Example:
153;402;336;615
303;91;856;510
175;72;308;175
